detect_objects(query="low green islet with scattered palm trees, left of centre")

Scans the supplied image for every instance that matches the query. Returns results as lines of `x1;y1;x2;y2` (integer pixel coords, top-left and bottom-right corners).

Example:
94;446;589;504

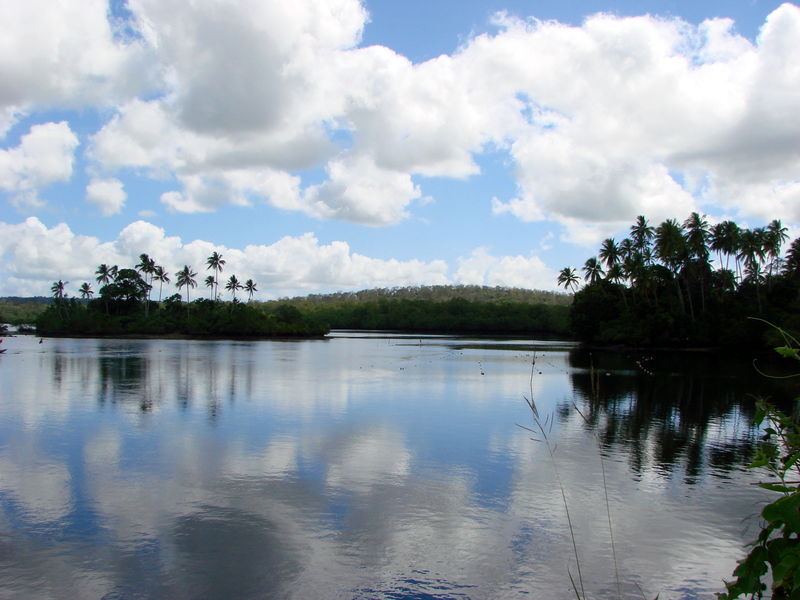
36;253;328;338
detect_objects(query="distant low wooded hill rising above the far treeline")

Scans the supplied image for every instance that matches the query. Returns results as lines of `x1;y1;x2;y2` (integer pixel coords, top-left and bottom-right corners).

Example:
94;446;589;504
273;285;572;306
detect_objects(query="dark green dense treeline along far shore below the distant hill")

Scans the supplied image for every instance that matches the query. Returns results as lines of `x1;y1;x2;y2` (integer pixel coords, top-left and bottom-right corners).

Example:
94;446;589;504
294;298;569;335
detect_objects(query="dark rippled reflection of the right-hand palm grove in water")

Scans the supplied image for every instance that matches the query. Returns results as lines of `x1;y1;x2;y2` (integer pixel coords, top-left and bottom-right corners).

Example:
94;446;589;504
561;350;793;483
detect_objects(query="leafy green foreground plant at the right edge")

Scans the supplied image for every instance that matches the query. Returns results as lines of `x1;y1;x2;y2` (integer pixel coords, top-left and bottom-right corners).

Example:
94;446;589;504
718;329;800;600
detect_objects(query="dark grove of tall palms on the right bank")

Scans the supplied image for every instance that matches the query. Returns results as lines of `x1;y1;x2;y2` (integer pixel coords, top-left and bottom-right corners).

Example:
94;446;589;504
558;213;800;349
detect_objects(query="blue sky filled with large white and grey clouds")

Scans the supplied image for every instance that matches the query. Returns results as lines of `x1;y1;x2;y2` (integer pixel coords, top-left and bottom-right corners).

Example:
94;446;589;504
0;0;800;300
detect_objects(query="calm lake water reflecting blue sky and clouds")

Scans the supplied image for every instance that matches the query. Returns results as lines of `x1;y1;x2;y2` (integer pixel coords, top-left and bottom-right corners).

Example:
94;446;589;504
0;332;788;599
